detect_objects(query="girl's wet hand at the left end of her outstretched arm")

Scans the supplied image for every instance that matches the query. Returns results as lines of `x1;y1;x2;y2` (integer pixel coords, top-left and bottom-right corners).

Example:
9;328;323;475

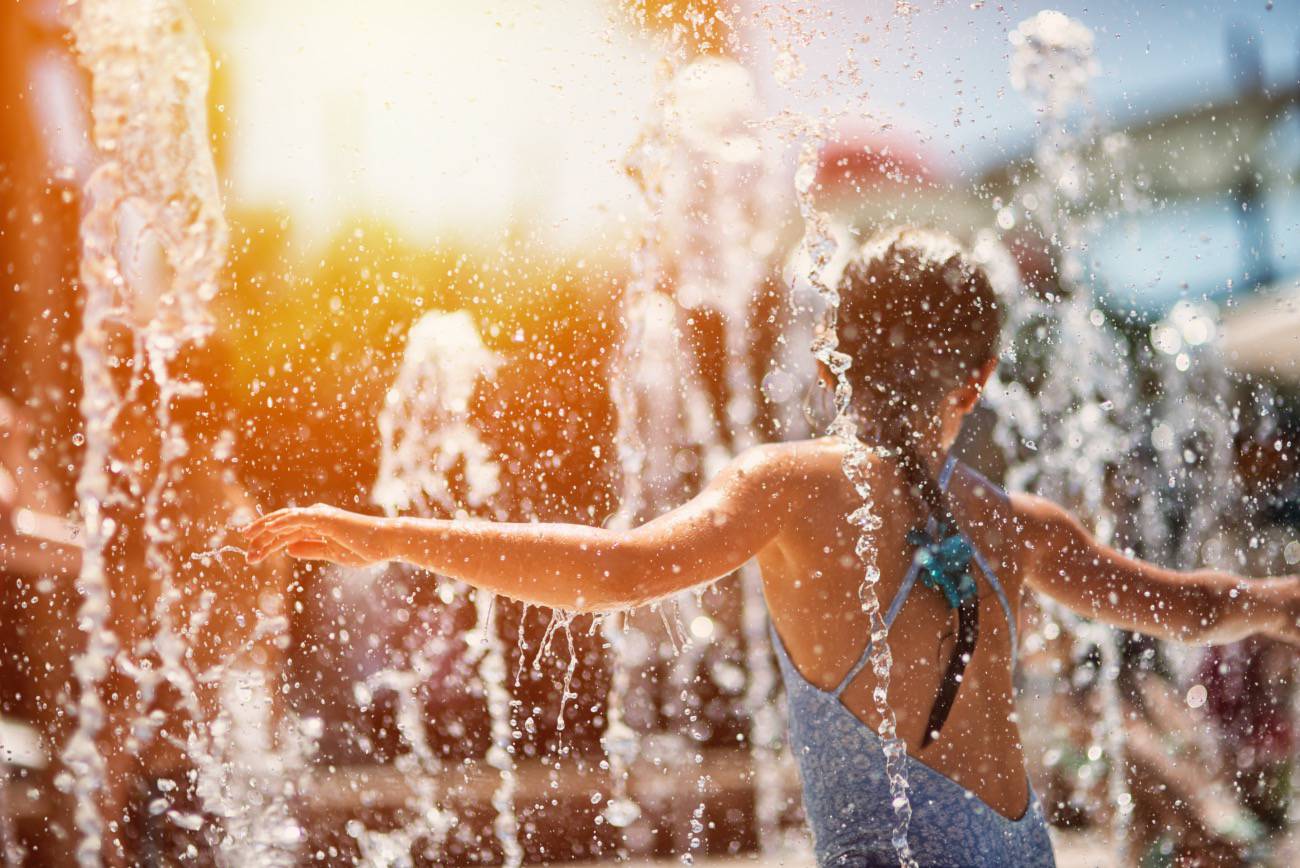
243;503;389;567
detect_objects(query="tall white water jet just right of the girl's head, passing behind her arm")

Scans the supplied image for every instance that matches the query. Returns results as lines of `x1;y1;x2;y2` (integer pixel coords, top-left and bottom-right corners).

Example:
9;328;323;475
987;10;1136;860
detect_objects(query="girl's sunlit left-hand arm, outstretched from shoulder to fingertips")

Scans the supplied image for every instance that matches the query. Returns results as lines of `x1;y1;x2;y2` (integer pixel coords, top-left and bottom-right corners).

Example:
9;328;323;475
244;446;788;611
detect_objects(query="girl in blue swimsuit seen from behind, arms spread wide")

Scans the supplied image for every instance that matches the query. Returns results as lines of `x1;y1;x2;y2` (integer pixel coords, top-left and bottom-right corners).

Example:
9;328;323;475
247;229;1300;867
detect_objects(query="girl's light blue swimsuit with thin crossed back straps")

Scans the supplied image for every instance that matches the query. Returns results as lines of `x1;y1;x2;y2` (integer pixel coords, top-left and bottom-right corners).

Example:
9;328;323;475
772;457;1056;868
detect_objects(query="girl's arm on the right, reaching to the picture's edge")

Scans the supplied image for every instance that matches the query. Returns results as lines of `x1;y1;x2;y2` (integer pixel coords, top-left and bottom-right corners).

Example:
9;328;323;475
1011;495;1300;645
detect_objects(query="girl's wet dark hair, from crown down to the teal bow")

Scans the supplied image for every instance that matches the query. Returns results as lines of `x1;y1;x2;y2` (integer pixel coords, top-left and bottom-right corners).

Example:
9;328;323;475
837;226;1001;525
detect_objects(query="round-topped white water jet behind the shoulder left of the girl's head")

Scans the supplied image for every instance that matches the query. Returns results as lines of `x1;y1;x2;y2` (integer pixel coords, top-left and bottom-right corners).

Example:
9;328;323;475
660;57;784;851
